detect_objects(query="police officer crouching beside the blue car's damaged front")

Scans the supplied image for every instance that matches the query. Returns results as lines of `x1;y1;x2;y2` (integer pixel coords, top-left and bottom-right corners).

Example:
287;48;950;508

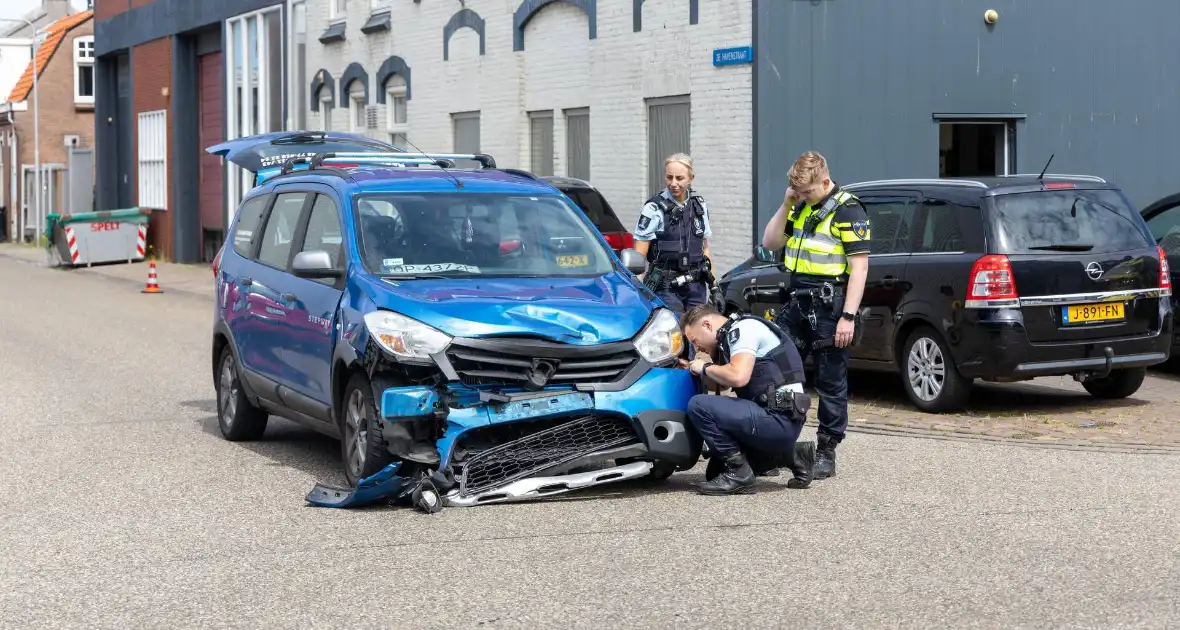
681;304;815;494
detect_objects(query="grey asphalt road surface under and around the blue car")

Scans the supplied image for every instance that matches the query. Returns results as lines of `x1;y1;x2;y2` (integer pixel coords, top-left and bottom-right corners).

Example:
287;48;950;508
0;256;1180;628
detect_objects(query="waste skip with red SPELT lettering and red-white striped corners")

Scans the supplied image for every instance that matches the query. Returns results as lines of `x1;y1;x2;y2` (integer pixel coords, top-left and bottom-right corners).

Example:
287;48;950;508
45;208;151;267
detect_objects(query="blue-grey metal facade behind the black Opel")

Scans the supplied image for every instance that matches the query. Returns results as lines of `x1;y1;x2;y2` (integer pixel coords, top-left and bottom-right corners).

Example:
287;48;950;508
754;0;1180;243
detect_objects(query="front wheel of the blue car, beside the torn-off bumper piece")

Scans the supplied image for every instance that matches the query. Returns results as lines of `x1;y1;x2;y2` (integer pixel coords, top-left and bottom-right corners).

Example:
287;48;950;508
339;372;395;487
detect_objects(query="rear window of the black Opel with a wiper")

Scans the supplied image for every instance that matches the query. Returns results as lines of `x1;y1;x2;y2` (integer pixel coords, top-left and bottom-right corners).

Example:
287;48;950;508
991;189;1154;254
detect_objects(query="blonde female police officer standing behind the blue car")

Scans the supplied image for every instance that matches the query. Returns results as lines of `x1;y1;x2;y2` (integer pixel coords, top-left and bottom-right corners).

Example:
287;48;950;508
635;153;714;315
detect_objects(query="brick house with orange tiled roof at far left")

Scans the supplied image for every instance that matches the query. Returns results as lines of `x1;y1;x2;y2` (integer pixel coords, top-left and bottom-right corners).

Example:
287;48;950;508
0;11;94;246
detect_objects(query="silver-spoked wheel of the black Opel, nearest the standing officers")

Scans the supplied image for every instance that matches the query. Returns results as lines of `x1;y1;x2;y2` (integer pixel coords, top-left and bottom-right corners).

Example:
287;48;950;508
898;326;971;413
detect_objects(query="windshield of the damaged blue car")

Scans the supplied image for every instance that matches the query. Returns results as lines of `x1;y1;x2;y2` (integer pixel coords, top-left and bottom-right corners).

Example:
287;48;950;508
356;192;615;280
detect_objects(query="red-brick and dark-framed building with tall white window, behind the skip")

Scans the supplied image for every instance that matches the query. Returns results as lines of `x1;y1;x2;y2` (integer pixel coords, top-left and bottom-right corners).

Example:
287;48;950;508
94;0;295;263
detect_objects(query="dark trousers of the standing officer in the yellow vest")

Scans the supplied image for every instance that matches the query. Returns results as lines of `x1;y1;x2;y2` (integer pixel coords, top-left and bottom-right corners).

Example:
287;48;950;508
775;294;848;444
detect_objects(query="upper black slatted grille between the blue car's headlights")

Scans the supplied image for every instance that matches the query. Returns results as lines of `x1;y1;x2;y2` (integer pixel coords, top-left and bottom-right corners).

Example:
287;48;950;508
447;340;640;386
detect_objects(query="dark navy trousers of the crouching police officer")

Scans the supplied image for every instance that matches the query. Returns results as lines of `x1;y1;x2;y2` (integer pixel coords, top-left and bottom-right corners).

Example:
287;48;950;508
688;394;804;458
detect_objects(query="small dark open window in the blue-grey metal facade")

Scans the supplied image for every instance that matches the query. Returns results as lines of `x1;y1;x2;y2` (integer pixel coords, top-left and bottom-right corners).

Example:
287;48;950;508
938;122;1015;177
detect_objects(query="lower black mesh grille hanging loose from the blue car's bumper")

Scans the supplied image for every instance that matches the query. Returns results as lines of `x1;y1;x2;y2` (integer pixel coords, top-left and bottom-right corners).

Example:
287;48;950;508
459;415;638;496
